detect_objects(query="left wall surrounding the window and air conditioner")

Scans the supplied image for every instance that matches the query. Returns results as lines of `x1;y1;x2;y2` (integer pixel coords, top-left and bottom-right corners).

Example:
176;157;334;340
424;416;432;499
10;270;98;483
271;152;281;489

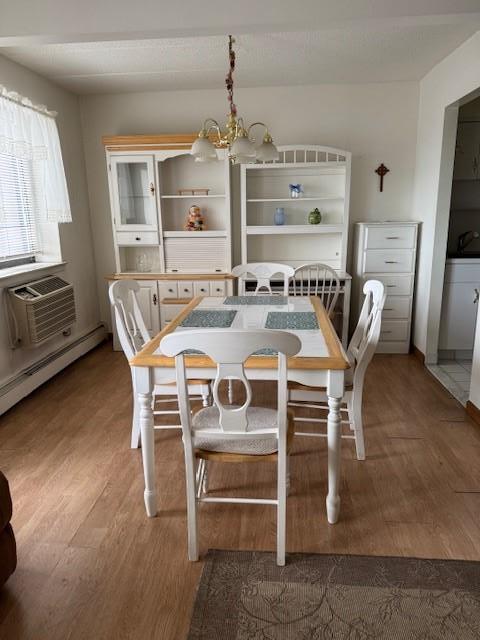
0;56;99;385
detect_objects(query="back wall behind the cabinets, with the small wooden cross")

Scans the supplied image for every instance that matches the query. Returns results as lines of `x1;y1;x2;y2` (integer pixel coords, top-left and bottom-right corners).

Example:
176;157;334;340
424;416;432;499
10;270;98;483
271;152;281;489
81;78;418;321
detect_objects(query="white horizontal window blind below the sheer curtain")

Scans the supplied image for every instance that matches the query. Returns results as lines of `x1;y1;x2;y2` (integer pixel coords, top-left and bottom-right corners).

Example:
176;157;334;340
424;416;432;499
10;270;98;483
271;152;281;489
0;152;38;261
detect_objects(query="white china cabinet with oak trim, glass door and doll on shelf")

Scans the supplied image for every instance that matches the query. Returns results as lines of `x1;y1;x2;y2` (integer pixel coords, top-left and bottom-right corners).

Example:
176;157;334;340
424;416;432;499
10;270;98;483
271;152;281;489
103;135;233;333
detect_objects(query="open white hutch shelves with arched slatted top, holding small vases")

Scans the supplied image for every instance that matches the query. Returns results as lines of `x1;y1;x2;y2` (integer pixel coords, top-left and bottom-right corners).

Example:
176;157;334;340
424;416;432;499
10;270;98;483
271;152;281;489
240;145;351;272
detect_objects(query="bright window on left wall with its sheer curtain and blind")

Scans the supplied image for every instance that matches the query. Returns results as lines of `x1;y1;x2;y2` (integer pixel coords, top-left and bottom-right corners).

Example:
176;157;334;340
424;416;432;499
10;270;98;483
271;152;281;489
0;85;72;268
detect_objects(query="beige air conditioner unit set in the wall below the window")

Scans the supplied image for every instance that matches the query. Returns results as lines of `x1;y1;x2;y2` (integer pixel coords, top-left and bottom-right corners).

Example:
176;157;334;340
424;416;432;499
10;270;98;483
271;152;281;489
8;276;76;347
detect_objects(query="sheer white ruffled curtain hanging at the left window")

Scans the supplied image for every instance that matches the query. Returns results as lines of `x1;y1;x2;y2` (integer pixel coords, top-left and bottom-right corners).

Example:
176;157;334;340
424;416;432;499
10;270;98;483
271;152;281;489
0;85;72;223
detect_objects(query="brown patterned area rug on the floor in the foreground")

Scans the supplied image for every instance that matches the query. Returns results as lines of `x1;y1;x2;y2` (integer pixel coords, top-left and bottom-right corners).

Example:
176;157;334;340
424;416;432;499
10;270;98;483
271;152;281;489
188;551;480;640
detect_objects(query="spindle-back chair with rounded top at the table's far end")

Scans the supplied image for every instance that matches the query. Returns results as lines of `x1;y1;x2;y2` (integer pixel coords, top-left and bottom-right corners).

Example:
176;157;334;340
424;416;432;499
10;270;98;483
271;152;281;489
293;262;340;317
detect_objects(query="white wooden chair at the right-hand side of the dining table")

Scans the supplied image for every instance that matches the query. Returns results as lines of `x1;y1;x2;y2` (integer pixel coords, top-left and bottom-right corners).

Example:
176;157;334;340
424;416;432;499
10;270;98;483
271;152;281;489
288;280;386;460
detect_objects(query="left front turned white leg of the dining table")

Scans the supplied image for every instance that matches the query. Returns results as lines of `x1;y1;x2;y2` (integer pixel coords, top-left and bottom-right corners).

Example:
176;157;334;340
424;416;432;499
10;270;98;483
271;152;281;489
135;367;157;518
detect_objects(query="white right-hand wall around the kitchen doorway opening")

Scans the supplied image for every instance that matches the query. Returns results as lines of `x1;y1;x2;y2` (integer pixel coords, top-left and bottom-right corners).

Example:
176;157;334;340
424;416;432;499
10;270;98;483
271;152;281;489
413;32;480;366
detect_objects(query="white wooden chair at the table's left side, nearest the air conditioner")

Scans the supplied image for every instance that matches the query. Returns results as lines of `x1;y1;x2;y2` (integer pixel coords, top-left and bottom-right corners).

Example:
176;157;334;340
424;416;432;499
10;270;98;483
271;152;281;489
108;280;210;449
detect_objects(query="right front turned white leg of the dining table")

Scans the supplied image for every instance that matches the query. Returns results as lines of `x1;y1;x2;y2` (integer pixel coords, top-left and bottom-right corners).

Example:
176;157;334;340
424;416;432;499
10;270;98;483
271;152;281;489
326;371;344;524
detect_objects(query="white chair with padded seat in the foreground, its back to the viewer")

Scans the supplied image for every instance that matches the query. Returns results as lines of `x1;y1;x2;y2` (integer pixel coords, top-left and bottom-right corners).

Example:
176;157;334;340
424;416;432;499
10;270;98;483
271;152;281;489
160;329;301;565
